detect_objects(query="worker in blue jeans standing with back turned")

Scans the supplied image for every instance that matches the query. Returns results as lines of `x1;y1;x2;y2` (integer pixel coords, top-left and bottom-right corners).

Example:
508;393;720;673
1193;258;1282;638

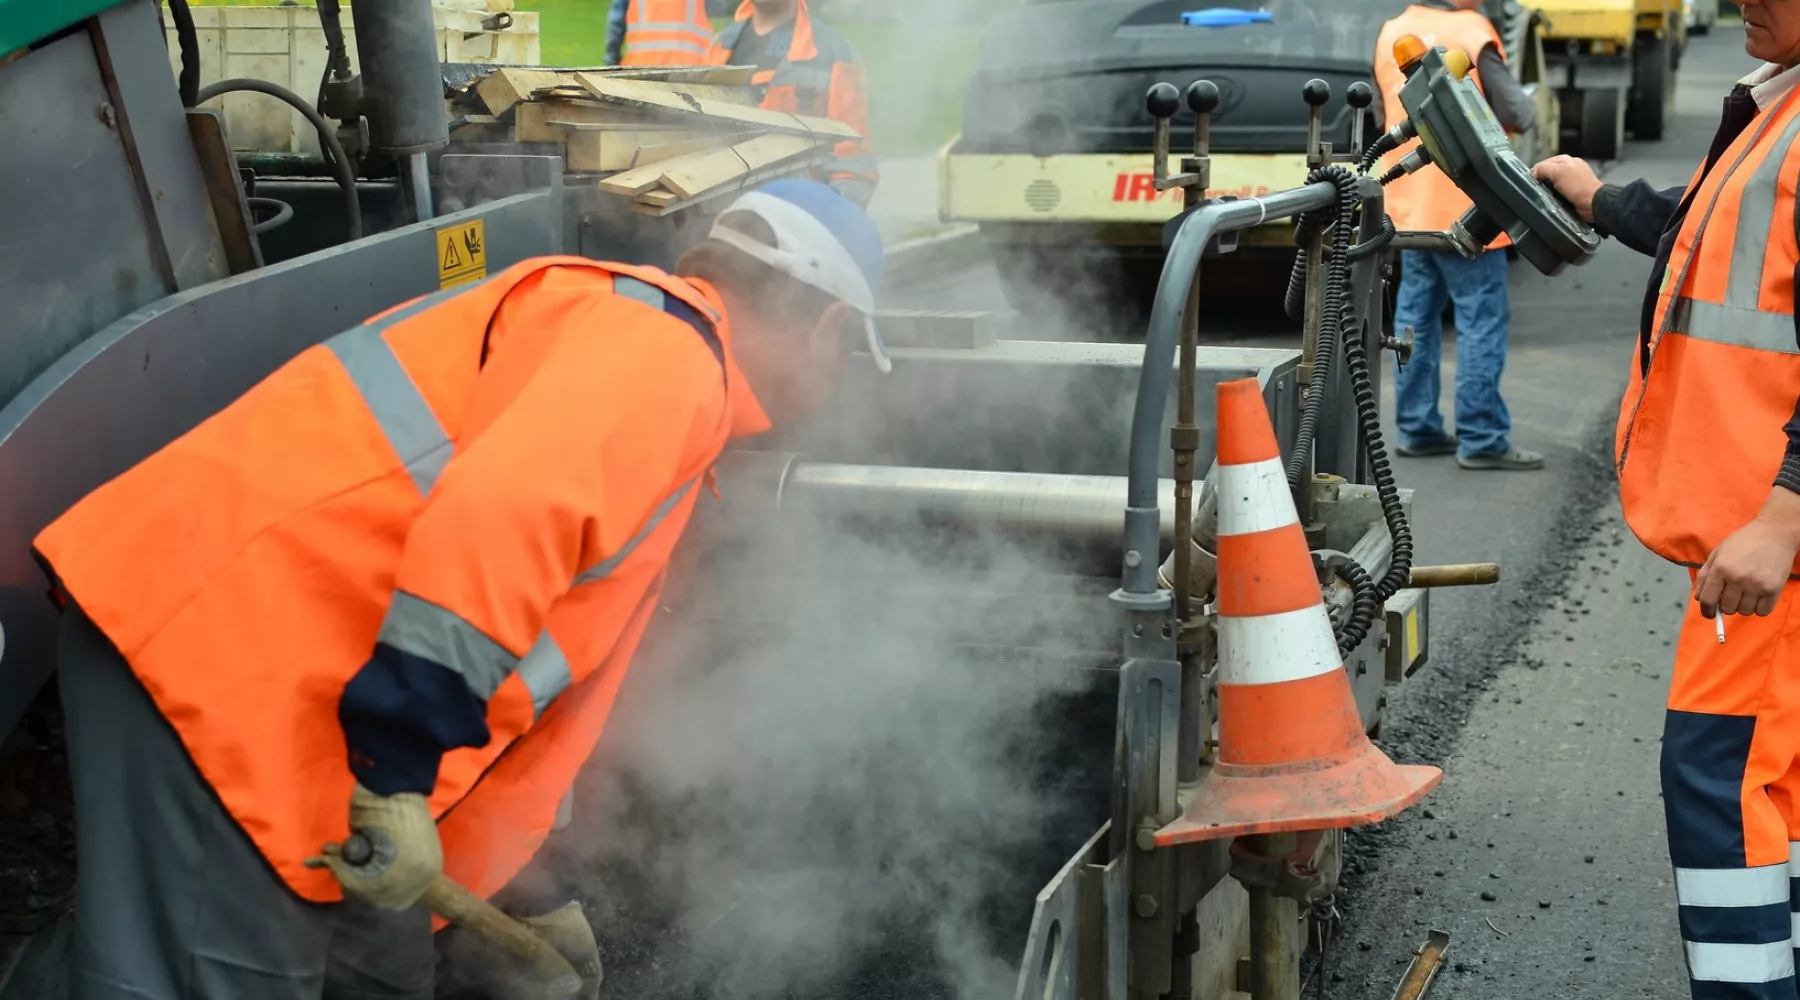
1375;0;1544;469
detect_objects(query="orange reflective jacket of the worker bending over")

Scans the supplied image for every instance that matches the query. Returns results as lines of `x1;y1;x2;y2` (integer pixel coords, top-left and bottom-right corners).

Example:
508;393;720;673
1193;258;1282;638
36;257;769;901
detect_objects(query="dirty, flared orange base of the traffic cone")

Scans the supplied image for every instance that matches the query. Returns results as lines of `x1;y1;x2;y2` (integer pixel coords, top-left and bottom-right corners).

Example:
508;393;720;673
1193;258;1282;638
1156;739;1444;847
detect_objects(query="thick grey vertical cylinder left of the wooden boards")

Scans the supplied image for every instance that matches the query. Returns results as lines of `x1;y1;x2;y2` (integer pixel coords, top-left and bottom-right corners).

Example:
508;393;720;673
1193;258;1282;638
351;0;450;156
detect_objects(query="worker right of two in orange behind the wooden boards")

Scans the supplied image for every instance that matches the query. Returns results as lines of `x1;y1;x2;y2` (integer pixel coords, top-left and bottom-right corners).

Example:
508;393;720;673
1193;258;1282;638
706;0;880;207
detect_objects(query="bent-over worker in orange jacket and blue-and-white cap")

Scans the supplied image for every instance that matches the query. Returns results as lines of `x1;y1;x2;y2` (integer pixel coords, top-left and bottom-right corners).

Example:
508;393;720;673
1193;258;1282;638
34;180;889;1000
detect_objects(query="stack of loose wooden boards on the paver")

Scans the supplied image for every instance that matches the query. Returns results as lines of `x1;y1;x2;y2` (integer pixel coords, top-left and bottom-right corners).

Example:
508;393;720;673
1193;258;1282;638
464;67;857;216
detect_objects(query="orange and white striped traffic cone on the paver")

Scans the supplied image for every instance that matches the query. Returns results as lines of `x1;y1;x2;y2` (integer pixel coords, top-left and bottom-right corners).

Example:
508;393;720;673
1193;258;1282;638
1156;378;1444;845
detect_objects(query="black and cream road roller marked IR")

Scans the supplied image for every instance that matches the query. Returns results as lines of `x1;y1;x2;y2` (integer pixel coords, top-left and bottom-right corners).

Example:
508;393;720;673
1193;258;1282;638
940;0;1557;313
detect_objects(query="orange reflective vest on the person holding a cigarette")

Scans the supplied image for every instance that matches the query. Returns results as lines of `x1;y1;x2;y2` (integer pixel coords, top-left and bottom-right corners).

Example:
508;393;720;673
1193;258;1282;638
1615;84;1800;567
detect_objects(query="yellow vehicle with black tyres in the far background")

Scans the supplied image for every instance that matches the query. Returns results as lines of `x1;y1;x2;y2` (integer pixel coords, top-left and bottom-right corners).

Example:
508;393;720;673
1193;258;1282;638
1526;0;1688;160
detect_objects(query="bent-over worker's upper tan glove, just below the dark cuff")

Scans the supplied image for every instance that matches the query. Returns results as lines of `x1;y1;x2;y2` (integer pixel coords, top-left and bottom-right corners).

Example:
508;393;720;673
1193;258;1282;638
306;784;445;910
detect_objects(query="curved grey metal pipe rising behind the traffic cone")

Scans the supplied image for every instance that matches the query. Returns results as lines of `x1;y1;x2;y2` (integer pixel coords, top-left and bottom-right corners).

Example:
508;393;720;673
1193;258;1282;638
1114;182;1337;608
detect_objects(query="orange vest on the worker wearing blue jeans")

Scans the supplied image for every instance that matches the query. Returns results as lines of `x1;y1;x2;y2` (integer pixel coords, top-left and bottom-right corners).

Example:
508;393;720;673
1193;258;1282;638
1375;4;1512;248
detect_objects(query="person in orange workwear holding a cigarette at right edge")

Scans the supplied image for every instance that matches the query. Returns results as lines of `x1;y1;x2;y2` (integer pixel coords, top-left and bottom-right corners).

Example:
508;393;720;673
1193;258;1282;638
1535;0;1800;1000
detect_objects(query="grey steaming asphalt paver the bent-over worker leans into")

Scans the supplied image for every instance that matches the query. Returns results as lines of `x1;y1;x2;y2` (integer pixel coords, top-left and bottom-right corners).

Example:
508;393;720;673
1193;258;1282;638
0;0;1597;1000
